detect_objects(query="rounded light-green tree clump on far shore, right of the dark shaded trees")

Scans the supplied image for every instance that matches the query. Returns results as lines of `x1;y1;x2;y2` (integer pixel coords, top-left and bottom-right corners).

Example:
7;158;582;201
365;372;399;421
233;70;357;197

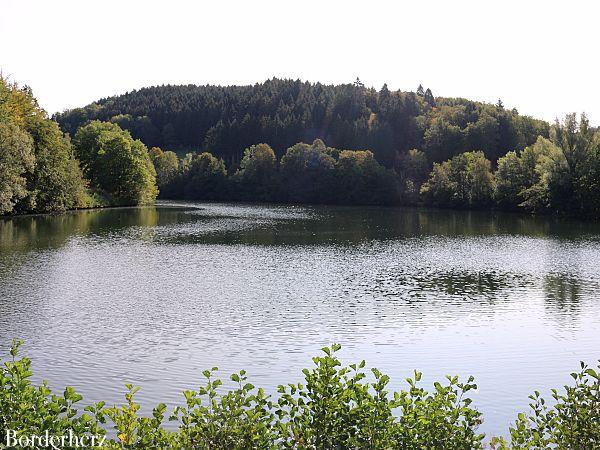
421;152;494;208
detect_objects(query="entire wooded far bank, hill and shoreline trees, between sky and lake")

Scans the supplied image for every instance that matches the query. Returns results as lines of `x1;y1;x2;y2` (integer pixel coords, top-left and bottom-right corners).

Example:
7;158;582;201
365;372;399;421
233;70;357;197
0;79;600;217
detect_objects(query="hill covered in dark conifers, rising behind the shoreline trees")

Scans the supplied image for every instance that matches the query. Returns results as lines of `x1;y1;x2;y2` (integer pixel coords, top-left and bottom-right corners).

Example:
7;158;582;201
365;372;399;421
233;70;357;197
55;79;549;167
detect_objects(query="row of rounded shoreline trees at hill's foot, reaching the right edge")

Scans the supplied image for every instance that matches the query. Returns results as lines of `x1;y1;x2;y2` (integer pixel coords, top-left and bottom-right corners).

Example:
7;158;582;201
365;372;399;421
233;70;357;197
150;114;600;217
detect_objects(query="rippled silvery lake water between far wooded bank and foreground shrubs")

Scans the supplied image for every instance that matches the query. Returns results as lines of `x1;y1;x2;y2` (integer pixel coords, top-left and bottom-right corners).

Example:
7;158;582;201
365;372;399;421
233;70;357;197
0;203;600;434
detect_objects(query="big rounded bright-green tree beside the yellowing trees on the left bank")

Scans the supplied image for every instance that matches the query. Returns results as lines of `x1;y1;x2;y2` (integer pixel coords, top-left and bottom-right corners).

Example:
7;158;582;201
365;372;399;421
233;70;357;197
74;121;158;205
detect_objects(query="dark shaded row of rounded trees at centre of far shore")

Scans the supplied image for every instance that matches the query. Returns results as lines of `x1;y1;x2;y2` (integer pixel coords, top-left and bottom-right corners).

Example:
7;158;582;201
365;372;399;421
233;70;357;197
162;139;399;204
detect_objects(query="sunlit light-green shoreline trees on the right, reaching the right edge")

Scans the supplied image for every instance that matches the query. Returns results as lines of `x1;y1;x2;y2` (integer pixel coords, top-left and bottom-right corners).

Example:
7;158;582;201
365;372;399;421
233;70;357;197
420;114;600;217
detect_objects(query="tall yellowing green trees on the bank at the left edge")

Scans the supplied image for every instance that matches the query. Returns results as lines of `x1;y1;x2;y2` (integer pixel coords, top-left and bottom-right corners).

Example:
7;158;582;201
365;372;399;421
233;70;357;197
0;77;89;214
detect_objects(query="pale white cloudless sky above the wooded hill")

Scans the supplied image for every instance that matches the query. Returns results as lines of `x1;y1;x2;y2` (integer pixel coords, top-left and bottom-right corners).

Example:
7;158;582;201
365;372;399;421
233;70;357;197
0;0;600;125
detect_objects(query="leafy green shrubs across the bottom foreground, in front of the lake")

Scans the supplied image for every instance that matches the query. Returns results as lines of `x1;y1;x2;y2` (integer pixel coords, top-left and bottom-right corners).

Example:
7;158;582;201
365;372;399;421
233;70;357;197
0;342;600;450
